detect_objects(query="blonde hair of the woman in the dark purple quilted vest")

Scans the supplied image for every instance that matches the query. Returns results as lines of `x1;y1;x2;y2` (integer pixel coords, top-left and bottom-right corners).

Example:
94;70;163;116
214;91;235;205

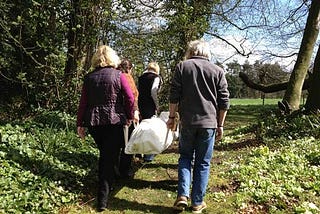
91;45;121;68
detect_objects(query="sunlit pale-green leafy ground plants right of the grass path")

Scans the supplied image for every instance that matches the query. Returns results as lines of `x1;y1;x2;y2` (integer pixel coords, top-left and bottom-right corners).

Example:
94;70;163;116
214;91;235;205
229;138;320;213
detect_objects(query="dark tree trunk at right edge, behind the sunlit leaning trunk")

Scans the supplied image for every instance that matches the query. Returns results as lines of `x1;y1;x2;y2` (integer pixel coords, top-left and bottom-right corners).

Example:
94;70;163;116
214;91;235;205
305;45;320;112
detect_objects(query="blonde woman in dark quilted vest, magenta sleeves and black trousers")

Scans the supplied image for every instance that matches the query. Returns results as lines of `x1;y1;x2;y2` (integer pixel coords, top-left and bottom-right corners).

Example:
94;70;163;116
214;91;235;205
77;45;134;211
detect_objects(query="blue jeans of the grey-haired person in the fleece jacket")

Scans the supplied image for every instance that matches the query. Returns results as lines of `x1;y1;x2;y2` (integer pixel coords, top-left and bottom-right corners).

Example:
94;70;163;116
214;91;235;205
178;128;215;206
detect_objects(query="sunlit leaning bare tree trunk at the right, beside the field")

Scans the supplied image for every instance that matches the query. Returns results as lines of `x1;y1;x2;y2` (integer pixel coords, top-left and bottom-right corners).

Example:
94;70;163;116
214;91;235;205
282;0;320;113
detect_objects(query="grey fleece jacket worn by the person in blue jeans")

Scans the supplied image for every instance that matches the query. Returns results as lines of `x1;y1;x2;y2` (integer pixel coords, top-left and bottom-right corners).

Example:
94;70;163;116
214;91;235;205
169;57;230;128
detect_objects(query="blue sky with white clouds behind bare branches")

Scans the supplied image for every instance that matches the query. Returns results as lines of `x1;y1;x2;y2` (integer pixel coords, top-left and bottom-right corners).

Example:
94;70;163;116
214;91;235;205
206;0;320;71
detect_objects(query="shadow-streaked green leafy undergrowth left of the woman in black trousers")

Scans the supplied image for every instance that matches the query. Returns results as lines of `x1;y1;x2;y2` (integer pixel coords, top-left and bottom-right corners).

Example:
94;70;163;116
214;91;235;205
0;117;97;213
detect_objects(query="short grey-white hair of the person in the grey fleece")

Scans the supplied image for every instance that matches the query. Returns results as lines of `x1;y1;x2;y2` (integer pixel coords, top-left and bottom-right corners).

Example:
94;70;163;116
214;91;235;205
185;40;210;59
